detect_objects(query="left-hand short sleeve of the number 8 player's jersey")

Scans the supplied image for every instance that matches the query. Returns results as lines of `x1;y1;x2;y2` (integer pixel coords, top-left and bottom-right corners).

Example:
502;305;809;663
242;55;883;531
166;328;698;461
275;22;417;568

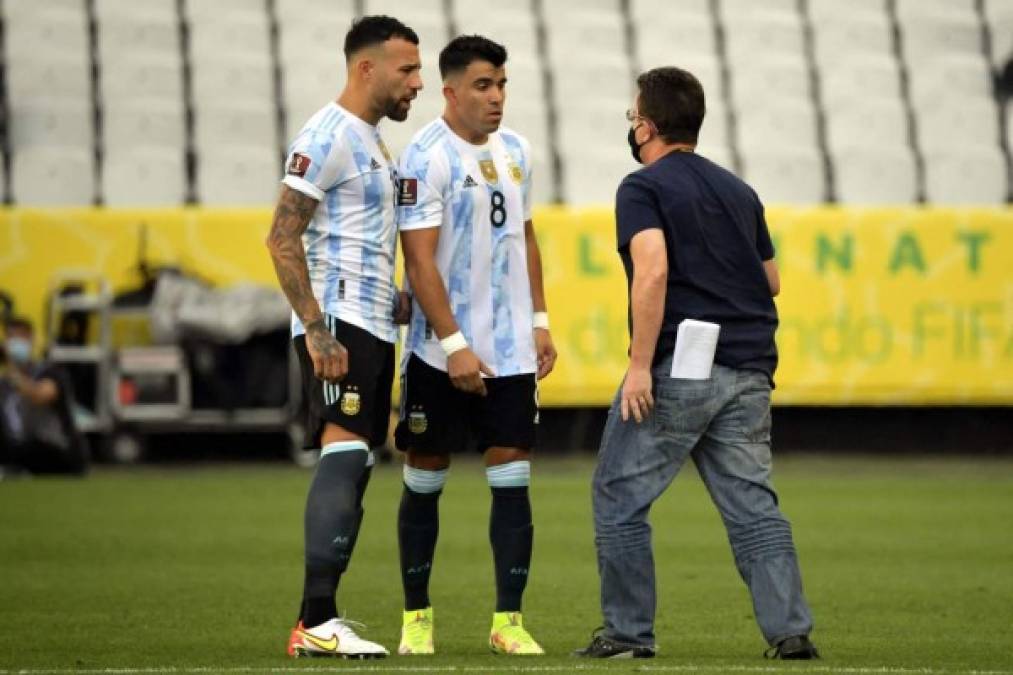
397;144;449;230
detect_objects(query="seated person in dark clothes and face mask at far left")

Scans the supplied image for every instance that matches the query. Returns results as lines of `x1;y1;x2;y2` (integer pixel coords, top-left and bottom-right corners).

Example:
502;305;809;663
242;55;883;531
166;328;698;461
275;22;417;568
0;318;88;474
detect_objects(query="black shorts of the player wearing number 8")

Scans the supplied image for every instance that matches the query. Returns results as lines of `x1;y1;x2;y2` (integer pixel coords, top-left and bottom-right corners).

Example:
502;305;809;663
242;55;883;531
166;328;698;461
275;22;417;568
394;354;538;455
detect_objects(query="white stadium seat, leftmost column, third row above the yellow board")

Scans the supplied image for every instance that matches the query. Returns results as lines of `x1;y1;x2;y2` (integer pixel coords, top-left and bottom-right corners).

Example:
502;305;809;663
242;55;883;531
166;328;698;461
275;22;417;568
4;52;91;101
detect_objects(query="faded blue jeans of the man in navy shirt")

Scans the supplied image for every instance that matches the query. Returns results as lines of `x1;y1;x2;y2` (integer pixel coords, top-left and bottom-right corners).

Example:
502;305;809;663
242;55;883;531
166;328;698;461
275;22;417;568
593;358;812;647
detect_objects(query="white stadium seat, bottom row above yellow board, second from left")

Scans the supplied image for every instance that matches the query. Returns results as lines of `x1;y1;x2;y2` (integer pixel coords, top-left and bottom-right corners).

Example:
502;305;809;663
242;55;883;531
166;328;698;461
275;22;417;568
102;145;186;207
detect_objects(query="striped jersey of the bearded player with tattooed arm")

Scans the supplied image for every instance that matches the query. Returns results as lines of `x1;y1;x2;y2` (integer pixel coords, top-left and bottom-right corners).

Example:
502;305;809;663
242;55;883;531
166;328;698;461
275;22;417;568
283;102;398;343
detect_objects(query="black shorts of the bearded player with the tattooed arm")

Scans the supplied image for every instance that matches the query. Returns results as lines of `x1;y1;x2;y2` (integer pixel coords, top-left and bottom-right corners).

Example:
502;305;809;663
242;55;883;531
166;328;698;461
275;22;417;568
293;314;394;449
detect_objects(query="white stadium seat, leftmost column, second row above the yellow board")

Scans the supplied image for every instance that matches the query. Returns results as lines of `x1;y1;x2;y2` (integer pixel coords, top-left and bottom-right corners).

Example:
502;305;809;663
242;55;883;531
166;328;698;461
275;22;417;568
8;96;94;152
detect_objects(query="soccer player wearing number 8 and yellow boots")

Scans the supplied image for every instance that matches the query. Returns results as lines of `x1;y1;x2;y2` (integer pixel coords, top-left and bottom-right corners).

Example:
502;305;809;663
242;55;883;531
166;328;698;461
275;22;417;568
395;35;556;655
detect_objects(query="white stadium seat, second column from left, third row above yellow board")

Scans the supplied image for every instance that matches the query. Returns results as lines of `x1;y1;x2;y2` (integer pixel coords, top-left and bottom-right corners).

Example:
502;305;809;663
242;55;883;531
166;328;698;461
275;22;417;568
99;55;183;103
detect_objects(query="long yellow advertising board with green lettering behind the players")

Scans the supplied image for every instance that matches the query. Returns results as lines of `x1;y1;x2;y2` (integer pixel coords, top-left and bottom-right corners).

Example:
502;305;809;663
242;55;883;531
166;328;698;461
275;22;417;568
0;207;1013;405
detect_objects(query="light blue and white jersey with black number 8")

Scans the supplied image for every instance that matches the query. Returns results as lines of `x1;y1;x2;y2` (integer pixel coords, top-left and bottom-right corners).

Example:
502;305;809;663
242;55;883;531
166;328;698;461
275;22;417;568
398;119;537;376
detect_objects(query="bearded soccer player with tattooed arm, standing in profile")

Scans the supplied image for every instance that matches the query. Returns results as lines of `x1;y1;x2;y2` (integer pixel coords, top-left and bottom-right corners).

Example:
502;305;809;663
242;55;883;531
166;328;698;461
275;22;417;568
267;16;422;659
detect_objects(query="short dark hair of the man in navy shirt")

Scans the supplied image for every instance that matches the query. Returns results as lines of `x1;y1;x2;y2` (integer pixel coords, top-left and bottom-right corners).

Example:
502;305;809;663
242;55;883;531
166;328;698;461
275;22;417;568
636;66;707;143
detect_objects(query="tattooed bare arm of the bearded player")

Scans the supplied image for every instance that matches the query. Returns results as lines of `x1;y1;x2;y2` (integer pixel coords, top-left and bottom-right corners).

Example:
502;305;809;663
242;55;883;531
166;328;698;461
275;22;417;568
266;185;348;382
